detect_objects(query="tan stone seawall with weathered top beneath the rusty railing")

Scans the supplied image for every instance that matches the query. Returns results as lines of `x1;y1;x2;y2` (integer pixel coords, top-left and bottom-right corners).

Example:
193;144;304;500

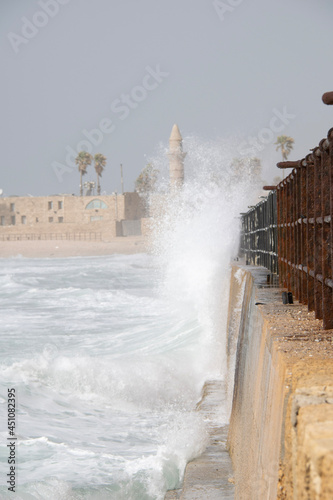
228;265;333;500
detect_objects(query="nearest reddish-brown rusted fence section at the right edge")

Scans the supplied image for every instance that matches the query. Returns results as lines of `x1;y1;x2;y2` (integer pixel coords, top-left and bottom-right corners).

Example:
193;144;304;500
277;134;333;329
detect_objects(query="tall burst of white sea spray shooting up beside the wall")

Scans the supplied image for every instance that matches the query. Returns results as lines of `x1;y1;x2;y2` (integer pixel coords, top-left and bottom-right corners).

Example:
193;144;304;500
150;137;260;380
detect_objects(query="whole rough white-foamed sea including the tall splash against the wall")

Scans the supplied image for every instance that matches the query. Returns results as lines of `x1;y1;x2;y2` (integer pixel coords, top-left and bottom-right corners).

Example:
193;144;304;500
0;139;256;500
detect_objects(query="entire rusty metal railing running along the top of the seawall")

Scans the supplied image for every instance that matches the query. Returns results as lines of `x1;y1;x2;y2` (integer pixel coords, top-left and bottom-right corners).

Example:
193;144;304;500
241;92;333;329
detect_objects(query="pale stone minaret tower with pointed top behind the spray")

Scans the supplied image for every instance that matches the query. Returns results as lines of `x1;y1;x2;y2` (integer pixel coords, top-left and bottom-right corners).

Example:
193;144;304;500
168;124;187;191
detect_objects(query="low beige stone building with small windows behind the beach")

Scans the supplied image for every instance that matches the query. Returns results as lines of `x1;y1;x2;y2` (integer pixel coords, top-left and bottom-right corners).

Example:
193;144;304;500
0;193;144;241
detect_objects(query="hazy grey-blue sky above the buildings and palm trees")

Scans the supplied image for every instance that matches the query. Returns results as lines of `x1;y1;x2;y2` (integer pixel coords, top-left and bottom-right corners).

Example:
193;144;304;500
0;0;333;195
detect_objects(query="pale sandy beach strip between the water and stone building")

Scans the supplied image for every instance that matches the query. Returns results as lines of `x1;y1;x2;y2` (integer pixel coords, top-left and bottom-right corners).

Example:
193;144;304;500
0;236;149;259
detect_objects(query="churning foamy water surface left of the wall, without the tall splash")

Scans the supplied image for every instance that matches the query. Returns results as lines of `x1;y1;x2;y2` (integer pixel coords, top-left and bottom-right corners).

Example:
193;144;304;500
0;255;224;499
